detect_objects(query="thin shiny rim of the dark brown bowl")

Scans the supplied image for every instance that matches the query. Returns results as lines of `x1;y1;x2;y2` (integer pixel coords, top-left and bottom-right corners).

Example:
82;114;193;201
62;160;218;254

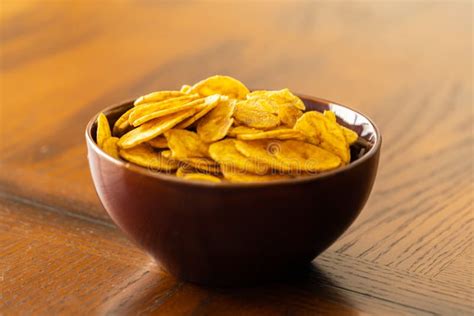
85;93;382;188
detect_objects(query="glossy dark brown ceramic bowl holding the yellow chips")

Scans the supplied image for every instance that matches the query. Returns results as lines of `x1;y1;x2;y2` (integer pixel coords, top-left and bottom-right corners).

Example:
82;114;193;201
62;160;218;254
86;96;381;285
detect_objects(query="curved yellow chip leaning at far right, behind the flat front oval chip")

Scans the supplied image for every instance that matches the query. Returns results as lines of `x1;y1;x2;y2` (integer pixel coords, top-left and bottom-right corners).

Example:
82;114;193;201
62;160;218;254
294;111;351;163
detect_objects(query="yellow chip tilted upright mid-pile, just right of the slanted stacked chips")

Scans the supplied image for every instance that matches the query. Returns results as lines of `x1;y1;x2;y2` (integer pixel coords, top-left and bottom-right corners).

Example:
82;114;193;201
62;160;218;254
196;100;235;142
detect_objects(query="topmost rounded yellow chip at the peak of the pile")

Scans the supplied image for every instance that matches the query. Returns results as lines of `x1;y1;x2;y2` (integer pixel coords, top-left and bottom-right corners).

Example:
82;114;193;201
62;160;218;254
191;75;249;99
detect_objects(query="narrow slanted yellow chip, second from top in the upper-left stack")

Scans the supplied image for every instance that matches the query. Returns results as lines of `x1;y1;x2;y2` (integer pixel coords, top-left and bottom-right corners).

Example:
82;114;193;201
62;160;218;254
129;95;204;126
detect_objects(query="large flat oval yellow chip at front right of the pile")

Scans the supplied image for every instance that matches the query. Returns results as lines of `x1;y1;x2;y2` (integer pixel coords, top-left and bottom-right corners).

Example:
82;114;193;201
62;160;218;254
275;140;341;172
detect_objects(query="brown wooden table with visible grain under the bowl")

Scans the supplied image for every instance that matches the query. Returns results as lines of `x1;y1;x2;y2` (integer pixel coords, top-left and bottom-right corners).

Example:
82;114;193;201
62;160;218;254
0;0;474;315
